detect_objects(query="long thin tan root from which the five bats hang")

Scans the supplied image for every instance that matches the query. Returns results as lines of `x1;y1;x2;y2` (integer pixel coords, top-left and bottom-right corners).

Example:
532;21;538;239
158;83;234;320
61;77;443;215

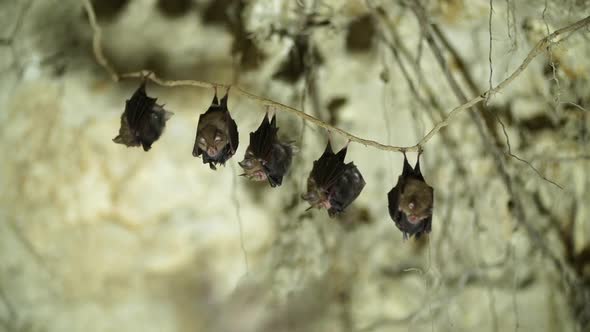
84;0;590;152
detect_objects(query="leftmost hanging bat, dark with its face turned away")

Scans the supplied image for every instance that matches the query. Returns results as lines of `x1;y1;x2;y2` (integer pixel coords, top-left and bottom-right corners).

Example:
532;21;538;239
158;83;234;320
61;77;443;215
113;81;174;151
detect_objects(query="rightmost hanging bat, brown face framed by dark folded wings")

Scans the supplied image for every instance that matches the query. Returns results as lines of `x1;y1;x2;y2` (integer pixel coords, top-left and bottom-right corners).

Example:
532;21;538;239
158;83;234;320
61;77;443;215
387;153;434;240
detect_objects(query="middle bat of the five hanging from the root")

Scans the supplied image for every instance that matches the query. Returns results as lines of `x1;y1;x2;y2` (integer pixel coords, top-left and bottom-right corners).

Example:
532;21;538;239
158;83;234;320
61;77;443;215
238;113;293;188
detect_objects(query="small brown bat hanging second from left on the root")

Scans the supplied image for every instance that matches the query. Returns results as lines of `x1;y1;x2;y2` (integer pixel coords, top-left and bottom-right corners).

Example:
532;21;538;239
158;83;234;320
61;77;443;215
193;89;239;170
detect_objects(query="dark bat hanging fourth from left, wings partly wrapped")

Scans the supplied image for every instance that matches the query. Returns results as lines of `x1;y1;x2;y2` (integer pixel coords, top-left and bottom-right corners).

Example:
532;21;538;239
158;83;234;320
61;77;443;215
302;140;365;217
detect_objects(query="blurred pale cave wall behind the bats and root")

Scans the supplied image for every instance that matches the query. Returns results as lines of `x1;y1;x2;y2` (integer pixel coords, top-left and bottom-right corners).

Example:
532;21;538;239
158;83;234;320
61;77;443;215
0;0;590;332
